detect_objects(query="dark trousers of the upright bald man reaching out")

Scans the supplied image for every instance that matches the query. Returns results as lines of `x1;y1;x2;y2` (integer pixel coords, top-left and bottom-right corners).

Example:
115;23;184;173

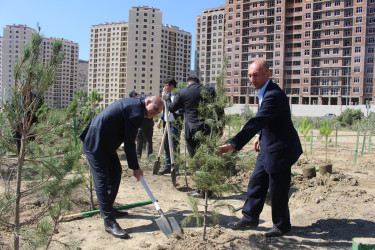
242;153;291;231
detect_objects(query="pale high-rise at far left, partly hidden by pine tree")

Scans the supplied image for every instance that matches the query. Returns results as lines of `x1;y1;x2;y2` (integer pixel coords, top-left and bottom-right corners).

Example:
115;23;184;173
0;25;79;108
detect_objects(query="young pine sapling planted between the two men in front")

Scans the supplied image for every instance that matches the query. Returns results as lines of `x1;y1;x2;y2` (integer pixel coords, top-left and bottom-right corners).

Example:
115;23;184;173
184;68;239;240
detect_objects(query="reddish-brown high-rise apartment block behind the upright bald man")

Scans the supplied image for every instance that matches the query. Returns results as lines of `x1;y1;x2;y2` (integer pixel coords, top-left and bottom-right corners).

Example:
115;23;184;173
195;0;375;105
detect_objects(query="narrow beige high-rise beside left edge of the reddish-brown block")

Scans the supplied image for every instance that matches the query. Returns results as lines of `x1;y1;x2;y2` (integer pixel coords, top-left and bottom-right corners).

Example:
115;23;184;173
195;5;225;86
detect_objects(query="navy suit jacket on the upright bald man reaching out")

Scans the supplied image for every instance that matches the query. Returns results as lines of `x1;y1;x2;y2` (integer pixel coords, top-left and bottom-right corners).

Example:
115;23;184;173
230;81;302;173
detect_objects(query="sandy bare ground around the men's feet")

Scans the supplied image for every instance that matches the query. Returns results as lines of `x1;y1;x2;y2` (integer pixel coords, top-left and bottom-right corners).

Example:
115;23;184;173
0;131;375;249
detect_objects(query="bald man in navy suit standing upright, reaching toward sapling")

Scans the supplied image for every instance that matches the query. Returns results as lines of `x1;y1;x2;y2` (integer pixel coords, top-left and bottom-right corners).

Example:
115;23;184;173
218;61;302;237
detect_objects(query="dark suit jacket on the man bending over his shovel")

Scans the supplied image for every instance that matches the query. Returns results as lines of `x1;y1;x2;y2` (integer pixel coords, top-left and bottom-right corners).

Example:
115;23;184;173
80;98;146;170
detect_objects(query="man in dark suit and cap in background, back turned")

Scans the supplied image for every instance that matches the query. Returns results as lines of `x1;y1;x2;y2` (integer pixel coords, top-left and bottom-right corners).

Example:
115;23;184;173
162;76;216;196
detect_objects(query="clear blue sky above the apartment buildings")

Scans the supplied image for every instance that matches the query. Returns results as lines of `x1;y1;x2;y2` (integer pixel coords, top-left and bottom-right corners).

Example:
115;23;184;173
0;0;225;67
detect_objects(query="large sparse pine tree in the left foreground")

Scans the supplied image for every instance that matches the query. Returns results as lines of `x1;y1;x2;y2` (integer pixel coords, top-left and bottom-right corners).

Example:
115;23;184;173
0;28;81;249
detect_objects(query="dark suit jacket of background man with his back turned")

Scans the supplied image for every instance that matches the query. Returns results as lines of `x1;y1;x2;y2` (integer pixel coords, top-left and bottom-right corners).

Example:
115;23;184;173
166;83;216;139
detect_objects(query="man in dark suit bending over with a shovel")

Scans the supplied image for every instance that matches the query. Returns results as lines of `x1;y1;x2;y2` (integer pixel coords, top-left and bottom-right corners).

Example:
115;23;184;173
80;96;164;238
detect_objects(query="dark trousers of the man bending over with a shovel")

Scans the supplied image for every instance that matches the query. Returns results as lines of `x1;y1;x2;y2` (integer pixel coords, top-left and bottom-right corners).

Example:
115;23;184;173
84;147;122;221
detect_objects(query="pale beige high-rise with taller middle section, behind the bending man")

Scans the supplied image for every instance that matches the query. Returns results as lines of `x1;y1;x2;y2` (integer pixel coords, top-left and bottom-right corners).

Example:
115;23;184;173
88;6;191;107
